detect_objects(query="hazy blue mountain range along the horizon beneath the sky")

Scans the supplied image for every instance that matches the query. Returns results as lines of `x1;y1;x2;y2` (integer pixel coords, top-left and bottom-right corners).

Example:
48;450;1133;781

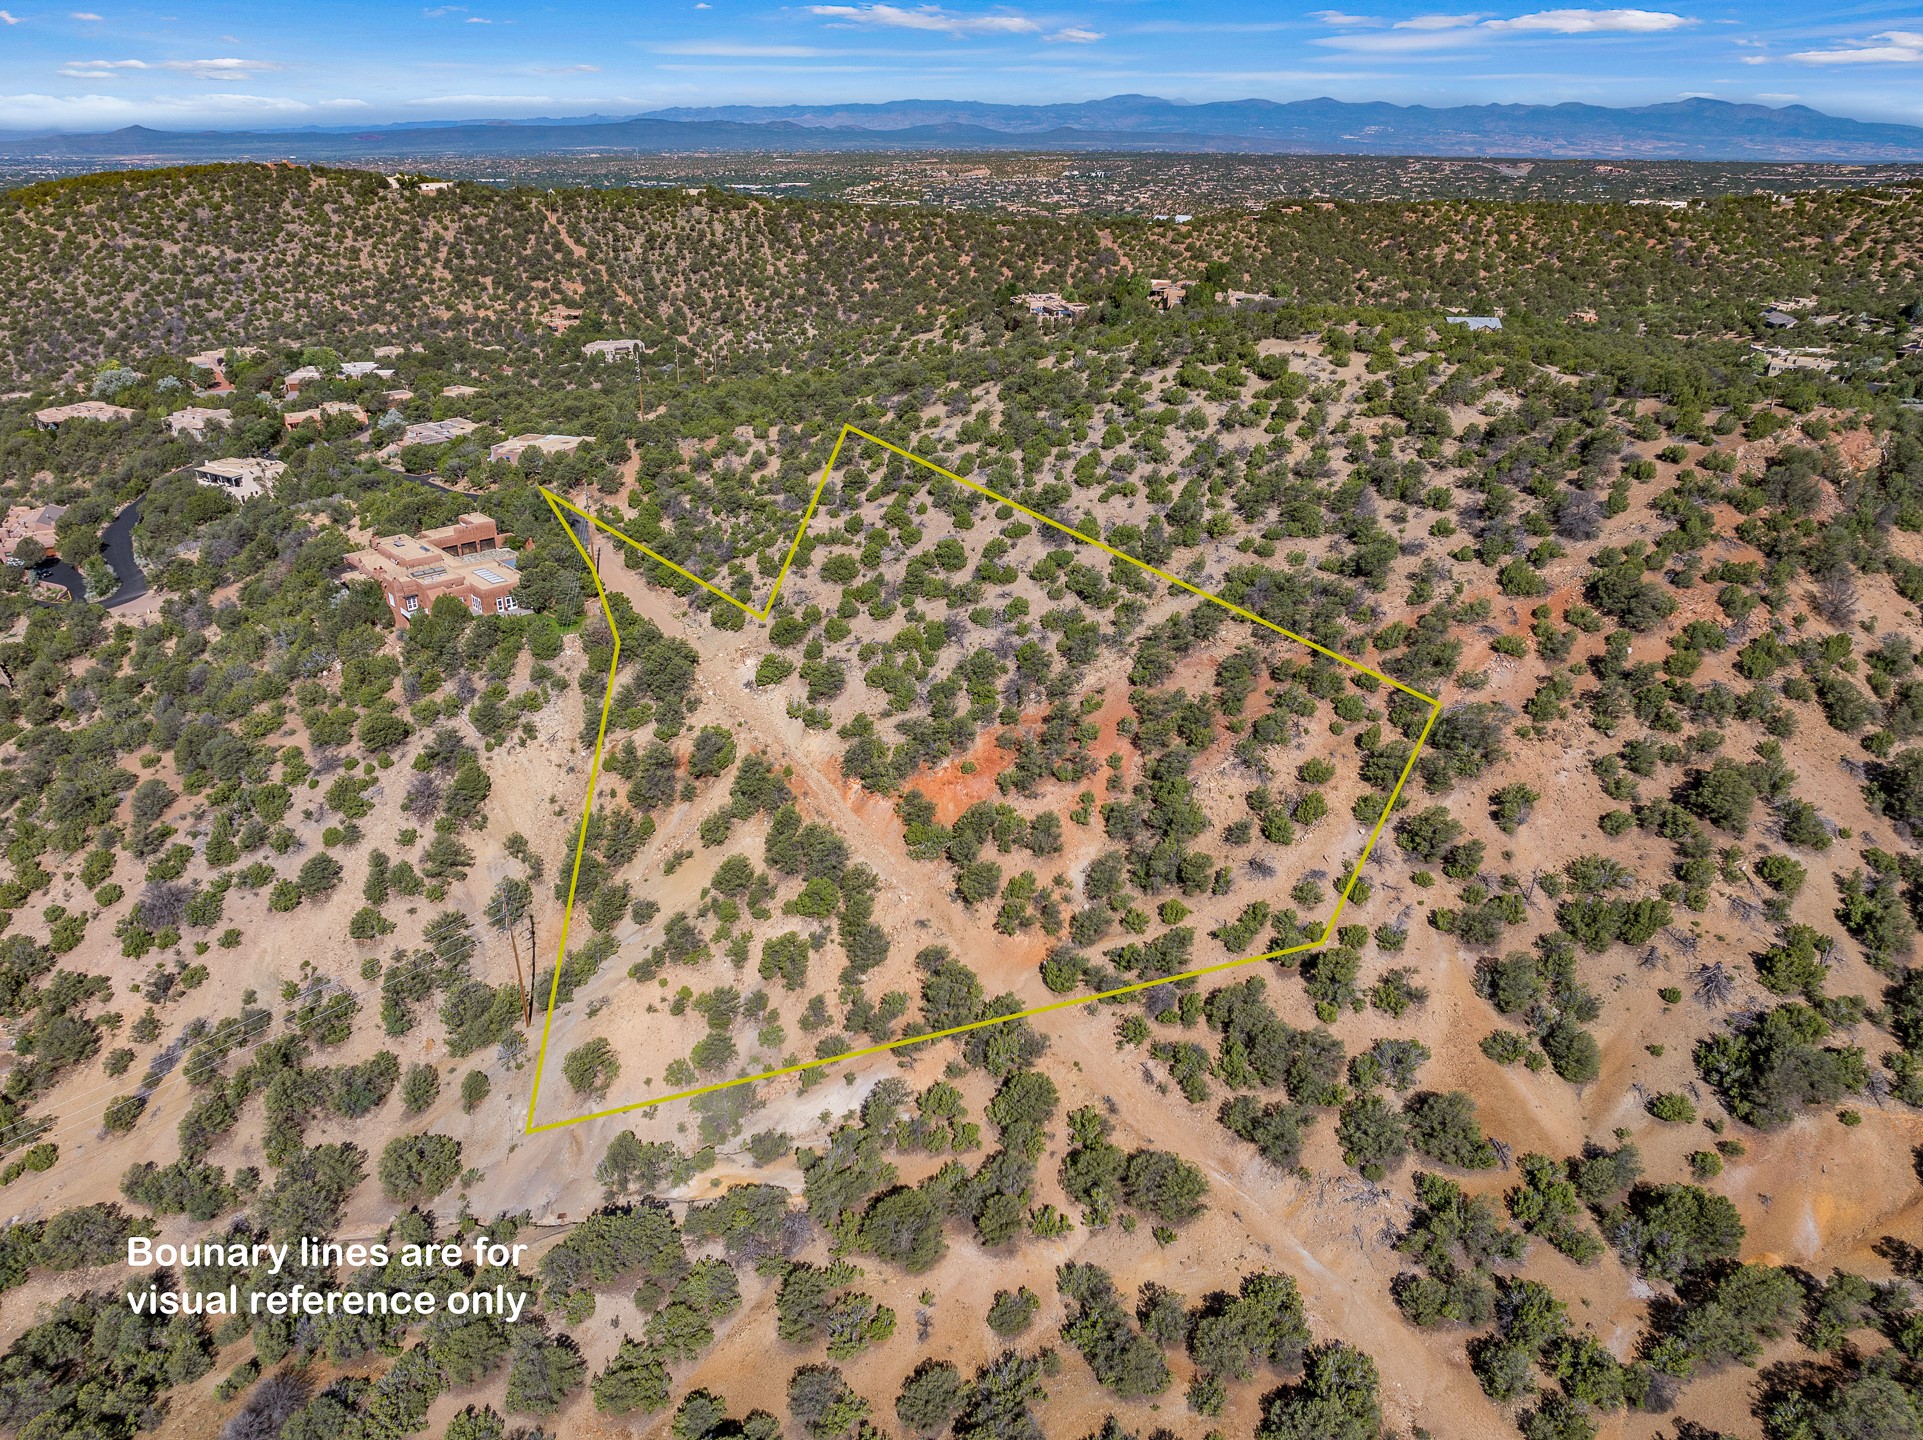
11;94;1923;163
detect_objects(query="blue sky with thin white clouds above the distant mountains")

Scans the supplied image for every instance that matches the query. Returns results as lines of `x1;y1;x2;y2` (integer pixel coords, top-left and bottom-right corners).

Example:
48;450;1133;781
0;0;1923;129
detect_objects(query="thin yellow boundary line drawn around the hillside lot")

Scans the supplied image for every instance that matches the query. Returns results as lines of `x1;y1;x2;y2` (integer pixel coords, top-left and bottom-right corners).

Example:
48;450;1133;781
525;425;1442;1134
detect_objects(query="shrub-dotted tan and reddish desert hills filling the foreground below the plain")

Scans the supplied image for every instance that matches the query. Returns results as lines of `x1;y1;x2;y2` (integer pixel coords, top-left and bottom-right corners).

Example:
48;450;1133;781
0;165;1923;1440
